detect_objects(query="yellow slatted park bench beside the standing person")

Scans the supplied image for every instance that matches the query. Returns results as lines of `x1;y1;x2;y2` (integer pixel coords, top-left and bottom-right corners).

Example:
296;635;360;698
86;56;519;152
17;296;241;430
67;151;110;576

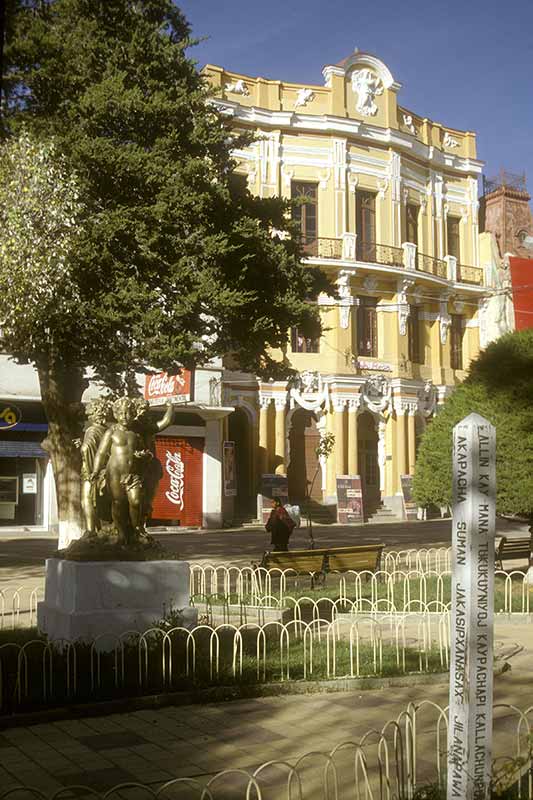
261;544;385;584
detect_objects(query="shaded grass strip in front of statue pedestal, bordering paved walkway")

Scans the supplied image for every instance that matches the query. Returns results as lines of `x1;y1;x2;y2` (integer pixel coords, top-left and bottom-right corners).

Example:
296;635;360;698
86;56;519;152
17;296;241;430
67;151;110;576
0;628;443;715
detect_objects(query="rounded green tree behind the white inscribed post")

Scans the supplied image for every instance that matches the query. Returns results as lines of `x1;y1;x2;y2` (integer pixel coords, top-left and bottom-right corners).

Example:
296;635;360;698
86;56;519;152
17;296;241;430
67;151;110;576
413;330;533;517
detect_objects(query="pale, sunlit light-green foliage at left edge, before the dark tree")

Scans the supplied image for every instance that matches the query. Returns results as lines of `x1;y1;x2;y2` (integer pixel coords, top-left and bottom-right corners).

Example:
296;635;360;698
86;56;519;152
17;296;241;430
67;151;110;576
0;131;83;363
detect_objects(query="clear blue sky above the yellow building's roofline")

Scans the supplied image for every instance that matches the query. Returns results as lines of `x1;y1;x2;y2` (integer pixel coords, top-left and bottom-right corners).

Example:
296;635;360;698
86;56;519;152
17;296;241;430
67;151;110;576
176;0;533;193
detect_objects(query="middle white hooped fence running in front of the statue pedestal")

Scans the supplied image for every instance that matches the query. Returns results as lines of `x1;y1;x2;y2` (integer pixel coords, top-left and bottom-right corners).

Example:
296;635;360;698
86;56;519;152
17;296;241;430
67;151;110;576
0;614;449;713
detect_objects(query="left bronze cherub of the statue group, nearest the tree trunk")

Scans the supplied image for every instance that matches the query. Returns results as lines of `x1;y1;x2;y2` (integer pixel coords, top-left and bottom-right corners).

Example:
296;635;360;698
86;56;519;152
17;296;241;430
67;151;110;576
76;397;111;537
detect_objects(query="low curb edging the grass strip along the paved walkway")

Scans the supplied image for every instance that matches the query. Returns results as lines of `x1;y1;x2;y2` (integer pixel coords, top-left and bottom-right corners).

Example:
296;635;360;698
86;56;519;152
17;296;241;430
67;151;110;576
0;661;511;730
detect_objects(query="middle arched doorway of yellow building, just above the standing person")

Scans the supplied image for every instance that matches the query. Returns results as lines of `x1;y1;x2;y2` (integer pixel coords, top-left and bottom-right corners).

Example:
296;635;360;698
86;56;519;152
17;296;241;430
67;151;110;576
287;408;322;505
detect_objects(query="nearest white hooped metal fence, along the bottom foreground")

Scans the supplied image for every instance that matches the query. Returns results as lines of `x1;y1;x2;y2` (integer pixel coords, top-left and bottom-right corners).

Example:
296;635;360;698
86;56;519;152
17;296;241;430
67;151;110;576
0;700;533;800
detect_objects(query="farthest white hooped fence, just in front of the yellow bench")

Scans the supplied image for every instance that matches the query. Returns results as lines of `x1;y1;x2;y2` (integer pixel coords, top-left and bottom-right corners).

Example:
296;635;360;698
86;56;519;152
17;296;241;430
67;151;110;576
4;562;533;630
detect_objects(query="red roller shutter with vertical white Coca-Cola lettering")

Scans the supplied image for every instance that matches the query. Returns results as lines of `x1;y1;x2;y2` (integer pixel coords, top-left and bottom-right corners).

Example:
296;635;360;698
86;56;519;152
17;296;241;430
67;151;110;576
152;436;204;527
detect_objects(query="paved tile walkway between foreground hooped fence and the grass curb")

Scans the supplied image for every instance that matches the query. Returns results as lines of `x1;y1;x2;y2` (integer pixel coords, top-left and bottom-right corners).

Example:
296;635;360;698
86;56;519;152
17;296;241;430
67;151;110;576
0;624;533;800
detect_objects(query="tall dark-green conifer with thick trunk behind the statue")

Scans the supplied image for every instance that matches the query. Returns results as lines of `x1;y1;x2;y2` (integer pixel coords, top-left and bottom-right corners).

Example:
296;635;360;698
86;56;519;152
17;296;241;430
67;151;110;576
0;0;330;544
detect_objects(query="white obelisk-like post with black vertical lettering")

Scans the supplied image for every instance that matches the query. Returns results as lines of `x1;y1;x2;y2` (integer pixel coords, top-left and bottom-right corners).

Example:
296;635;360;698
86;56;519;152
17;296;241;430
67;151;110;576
447;414;496;800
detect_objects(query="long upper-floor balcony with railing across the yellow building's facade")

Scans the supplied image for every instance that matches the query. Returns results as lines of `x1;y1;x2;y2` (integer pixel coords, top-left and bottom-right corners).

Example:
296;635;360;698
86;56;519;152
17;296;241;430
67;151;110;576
302;233;483;286
